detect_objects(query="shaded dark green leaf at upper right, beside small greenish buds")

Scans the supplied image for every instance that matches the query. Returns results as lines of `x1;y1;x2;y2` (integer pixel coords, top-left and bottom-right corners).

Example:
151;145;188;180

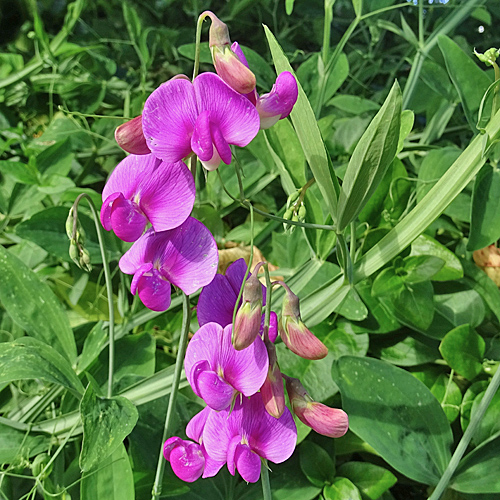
438;35;492;132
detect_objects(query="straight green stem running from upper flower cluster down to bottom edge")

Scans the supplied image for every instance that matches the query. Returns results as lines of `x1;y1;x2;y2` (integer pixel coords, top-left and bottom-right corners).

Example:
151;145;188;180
151;293;191;500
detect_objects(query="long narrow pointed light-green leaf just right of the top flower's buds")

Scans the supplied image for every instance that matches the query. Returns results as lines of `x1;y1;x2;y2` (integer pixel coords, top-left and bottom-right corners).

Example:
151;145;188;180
264;26;337;223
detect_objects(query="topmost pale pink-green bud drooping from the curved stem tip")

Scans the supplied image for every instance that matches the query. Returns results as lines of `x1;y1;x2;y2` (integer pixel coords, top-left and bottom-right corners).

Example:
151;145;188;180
202;11;256;94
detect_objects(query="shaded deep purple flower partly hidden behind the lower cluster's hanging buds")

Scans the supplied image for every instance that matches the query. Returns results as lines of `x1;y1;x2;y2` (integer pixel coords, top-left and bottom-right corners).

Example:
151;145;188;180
197;259;278;342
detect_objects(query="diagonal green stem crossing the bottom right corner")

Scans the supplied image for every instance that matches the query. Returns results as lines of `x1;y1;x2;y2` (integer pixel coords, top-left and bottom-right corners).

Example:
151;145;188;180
428;362;500;500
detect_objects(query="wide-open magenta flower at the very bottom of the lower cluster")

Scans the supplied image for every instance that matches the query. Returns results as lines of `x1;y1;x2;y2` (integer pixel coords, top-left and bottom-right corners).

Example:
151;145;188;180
203;394;297;483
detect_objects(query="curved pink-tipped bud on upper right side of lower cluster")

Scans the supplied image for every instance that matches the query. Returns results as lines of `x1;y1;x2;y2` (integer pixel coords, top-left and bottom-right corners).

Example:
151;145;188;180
278;282;328;359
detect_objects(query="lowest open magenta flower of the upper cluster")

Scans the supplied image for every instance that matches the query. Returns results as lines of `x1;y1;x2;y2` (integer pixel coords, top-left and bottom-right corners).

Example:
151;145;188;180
119;217;219;311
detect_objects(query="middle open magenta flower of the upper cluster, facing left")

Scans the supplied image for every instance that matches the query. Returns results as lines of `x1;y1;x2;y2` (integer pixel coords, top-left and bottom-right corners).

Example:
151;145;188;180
101;154;195;241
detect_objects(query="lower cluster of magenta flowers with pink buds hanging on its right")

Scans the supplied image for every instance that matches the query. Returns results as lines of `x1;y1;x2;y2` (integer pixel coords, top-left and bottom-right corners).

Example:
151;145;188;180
164;259;348;482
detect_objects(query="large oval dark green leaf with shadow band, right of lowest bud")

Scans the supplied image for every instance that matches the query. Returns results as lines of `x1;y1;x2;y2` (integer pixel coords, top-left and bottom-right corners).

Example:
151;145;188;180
332;356;453;485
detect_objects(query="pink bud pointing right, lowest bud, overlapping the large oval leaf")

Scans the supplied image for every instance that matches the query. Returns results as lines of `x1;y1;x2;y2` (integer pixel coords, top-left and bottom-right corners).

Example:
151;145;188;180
285;377;349;437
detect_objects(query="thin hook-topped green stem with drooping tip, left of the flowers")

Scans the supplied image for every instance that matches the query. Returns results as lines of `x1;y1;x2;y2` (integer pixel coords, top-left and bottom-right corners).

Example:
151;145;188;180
73;193;115;398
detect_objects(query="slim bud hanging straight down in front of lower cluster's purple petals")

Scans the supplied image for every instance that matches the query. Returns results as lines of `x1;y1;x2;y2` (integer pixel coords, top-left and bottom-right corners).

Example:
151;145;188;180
232;264;262;351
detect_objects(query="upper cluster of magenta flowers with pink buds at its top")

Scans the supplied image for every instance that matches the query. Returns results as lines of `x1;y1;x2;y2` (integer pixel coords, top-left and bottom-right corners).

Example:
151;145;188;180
101;12;298;311
